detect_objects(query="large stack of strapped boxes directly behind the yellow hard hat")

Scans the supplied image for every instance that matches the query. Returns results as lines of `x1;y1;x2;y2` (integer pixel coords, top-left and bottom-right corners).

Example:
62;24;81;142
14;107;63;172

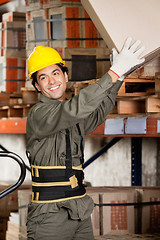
26;0;109;81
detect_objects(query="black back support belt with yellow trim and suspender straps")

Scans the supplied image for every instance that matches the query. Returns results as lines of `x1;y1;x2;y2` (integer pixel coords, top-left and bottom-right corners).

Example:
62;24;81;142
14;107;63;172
31;124;86;203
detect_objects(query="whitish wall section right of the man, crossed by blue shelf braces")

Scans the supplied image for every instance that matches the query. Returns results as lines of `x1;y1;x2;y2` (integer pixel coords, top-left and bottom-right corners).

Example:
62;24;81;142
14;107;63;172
85;138;157;186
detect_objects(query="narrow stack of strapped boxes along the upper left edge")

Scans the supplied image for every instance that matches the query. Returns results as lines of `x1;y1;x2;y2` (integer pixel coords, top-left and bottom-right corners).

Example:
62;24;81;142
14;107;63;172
0;12;26;92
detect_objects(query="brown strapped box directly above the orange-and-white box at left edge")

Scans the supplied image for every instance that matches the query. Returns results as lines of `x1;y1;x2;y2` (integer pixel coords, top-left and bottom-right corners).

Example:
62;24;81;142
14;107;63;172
0;22;26;57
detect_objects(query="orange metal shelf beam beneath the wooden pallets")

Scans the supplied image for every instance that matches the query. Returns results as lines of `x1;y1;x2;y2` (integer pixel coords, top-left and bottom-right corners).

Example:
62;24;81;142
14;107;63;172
0;114;160;137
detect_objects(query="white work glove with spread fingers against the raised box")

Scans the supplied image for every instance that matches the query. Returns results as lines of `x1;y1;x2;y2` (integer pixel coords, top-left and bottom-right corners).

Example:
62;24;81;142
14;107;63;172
110;37;145;78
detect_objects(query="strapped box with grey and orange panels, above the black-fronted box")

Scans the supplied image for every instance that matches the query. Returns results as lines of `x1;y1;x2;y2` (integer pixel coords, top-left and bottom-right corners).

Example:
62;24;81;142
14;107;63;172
49;6;106;48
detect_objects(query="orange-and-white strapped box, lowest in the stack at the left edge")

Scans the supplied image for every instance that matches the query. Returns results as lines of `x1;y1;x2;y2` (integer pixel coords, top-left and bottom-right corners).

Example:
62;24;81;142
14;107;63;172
0;57;26;92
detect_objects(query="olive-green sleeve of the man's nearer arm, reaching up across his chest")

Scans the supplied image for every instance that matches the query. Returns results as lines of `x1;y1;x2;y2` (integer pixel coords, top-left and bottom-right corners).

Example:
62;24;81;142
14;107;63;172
27;73;121;139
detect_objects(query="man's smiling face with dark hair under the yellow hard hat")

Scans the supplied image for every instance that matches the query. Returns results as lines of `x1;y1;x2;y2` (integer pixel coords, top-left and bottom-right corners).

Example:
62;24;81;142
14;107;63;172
35;64;68;101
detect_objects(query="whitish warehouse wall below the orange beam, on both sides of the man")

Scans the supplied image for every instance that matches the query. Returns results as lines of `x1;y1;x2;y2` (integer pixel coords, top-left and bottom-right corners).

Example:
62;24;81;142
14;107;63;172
0;134;157;186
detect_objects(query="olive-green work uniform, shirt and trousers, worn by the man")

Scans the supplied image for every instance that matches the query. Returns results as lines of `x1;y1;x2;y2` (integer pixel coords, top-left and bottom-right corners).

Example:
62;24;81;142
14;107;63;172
27;73;122;240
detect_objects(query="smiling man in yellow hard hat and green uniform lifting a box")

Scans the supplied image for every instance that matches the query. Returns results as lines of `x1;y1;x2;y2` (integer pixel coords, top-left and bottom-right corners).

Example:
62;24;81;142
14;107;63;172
27;38;144;240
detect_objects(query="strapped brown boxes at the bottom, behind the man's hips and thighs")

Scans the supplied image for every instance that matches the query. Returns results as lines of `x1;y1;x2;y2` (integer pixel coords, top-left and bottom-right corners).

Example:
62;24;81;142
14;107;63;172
15;187;160;239
